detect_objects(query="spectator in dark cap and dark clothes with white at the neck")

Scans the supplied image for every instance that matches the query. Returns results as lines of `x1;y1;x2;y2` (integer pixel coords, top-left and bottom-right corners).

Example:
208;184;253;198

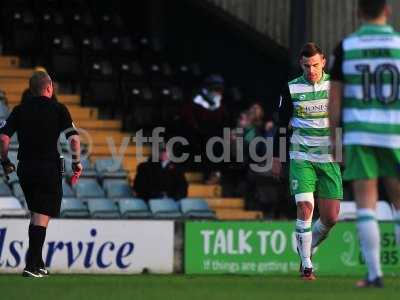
182;75;227;184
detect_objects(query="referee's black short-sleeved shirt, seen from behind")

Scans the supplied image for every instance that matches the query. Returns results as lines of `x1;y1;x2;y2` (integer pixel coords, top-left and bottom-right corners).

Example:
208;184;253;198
0;96;78;161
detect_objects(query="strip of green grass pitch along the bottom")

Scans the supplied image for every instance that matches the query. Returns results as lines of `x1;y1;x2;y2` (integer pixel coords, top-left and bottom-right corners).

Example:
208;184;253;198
0;274;400;300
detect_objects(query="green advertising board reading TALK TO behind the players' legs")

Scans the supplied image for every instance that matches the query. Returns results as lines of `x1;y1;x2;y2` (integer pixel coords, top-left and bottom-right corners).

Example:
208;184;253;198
185;222;400;275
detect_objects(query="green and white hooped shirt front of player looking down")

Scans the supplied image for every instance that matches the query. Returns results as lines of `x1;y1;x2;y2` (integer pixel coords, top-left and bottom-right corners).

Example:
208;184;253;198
289;73;333;163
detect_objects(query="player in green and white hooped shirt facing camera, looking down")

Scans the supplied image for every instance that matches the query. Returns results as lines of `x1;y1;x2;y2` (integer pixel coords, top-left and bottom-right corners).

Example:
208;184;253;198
272;43;343;280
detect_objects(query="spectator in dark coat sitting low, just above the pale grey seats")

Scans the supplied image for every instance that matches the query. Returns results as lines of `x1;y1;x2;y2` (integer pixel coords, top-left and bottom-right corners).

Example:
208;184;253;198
133;146;188;201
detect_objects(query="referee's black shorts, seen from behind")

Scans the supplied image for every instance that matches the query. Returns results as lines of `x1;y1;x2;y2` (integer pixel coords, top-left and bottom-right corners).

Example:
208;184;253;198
17;161;62;218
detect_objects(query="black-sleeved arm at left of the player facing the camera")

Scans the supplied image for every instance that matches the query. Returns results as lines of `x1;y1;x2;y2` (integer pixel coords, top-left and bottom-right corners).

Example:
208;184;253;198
272;84;293;178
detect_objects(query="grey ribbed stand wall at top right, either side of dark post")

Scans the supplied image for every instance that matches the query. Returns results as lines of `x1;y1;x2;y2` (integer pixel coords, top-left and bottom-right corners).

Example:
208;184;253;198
209;0;400;53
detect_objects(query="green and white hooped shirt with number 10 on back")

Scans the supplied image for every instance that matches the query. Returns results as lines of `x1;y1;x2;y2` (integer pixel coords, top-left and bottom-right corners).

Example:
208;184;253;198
332;25;400;149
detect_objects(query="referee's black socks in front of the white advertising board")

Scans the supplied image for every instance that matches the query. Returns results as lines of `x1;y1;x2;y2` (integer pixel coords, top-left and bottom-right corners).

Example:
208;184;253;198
26;224;47;271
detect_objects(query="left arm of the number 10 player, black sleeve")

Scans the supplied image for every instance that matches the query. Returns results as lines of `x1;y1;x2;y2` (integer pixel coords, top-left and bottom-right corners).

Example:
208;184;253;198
328;43;343;159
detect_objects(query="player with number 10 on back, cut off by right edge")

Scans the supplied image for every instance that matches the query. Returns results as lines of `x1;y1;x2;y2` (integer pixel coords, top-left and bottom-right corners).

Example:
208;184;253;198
329;0;400;287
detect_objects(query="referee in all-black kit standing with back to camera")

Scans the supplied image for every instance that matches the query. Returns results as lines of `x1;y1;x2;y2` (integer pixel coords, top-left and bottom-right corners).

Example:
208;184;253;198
0;71;82;278
